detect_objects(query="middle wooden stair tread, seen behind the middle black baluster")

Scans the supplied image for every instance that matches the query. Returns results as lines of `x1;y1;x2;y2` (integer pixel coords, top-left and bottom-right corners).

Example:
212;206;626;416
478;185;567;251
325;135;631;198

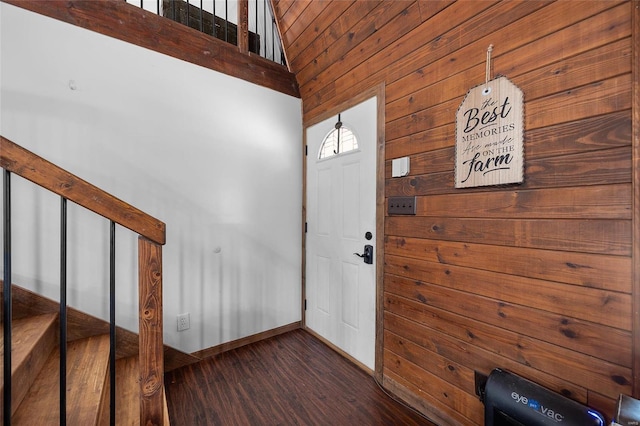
12;335;109;425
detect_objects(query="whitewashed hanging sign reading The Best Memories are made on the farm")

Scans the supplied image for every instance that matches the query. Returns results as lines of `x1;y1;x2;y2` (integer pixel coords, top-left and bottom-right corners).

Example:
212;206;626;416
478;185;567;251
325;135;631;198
455;46;524;188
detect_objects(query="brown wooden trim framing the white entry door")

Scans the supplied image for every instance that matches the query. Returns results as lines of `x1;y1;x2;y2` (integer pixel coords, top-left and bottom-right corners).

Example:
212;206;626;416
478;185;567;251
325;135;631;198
301;82;386;382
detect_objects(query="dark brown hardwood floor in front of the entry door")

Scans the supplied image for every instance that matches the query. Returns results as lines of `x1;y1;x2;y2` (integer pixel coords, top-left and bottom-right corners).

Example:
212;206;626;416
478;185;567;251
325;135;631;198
165;330;435;426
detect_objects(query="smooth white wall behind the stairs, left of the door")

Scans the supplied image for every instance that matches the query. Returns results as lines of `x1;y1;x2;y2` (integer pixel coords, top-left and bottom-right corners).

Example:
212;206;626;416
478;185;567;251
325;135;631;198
0;3;302;352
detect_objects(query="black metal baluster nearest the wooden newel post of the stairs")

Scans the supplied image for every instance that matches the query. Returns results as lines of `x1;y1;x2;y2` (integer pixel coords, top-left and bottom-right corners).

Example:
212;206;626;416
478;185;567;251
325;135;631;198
109;221;116;426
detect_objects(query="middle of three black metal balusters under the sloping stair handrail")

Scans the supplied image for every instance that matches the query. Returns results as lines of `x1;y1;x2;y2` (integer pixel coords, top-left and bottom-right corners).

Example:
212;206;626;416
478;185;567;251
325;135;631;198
60;197;67;426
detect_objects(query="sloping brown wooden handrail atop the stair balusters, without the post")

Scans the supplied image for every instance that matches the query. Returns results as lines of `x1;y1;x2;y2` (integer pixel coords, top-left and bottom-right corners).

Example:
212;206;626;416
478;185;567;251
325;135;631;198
0;136;166;245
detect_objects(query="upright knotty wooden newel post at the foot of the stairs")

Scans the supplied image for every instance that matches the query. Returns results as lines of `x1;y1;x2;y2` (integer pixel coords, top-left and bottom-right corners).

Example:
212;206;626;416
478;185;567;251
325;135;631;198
138;237;169;425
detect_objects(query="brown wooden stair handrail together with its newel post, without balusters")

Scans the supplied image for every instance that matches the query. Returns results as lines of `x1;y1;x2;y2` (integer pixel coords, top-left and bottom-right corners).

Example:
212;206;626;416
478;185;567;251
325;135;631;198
0;136;169;425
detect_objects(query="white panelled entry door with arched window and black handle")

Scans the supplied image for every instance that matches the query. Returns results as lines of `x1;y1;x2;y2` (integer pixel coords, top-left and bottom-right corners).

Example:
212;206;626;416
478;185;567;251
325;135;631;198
305;97;377;370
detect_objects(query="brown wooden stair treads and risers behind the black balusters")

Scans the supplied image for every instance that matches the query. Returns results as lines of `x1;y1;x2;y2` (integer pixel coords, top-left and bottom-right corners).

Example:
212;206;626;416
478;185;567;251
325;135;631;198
0;286;168;426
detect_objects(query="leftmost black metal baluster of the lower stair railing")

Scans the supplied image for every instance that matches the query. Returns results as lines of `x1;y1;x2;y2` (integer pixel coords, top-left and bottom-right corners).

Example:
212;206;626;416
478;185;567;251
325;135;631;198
2;170;12;426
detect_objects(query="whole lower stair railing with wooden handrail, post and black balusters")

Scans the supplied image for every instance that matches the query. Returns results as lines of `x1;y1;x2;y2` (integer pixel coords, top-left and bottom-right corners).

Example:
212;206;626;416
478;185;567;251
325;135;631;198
0;136;169;425
